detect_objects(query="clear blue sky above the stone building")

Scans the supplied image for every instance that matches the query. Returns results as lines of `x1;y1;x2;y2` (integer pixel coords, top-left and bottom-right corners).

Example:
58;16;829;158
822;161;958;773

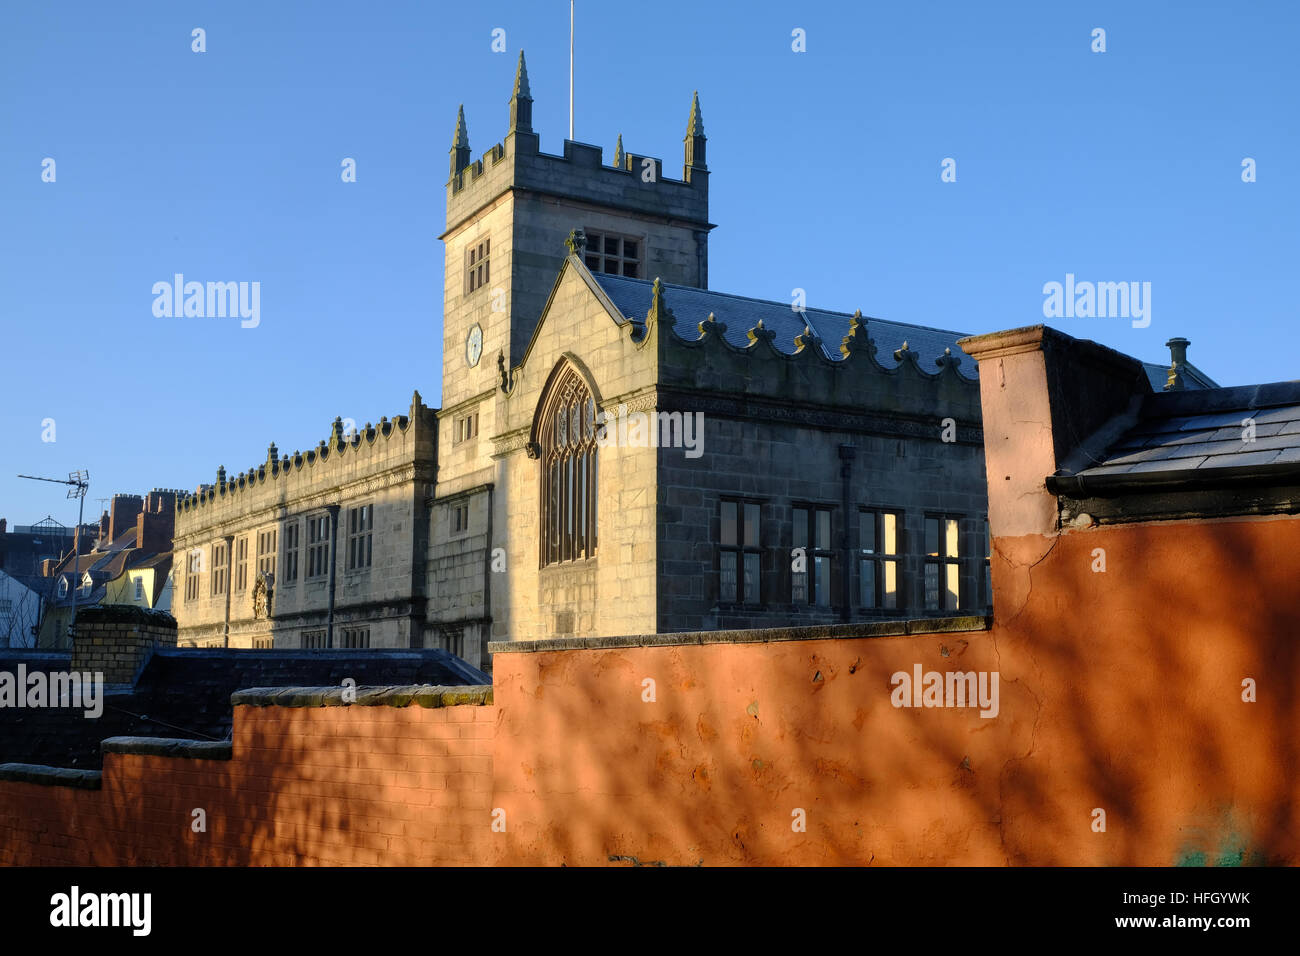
0;0;1300;527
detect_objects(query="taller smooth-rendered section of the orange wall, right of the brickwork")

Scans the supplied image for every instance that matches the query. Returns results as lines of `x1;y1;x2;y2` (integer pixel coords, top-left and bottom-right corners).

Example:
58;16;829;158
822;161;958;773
494;518;1300;865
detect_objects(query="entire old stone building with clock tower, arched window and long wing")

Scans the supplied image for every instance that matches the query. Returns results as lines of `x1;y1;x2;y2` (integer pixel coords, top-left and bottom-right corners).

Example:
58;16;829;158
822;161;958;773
167;55;1213;666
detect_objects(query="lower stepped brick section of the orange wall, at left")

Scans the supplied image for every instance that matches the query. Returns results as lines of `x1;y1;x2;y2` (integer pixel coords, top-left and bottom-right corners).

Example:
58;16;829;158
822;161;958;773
0;705;495;866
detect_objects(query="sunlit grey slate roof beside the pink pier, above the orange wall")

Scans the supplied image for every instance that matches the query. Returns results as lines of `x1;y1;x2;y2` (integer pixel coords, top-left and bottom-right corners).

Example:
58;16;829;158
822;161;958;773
1053;381;1300;493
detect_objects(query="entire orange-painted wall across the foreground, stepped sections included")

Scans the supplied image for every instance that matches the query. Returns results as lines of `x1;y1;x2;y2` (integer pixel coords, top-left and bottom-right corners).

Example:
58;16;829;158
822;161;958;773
0;518;1300;865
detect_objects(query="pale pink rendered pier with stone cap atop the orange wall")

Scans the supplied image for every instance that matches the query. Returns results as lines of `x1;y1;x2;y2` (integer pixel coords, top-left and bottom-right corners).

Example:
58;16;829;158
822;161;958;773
958;325;1151;538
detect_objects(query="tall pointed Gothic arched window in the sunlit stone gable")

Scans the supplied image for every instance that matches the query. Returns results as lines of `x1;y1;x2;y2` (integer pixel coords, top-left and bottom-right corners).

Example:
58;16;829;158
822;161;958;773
538;368;599;567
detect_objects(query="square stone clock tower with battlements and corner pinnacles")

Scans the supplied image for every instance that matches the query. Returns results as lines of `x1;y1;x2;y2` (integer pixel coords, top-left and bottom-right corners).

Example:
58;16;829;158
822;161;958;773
438;52;712;481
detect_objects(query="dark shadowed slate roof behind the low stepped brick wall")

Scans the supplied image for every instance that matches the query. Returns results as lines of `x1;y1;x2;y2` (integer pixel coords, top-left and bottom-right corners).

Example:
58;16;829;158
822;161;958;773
0;648;491;770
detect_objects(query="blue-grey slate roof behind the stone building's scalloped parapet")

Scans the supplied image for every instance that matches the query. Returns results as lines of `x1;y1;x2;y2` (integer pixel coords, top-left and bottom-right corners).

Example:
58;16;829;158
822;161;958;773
592;272;978;378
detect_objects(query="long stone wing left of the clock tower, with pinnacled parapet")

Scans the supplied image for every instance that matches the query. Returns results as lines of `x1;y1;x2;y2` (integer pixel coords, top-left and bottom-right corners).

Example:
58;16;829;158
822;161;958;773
173;392;437;648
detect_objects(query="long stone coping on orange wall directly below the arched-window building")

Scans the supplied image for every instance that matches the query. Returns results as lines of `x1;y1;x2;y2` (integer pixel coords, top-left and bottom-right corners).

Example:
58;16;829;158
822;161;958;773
488;615;993;654
